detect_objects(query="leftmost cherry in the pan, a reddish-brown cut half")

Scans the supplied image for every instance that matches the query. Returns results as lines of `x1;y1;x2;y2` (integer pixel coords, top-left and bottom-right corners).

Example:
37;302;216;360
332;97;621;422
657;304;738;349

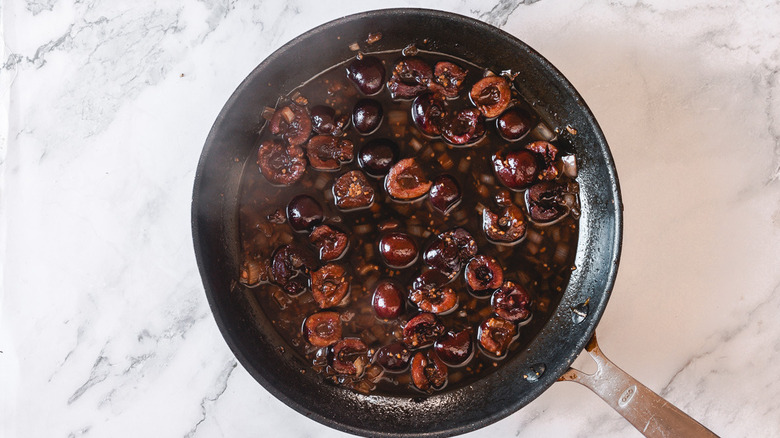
257;140;306;185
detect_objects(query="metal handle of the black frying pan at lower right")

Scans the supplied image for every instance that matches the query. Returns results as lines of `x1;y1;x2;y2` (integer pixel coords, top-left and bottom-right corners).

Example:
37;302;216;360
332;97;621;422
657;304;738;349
558;333;717;437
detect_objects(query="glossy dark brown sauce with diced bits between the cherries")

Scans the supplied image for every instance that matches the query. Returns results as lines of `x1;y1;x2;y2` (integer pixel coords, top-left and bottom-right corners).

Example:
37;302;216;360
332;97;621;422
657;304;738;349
235;52;578;396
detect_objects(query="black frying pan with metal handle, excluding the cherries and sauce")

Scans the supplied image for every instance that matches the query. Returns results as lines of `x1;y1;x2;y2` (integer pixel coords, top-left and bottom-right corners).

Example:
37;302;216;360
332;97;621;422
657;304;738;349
192;9;712;437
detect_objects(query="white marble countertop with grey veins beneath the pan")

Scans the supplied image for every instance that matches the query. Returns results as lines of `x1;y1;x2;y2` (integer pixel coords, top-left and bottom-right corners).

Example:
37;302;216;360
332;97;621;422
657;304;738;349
0;0;780;438
